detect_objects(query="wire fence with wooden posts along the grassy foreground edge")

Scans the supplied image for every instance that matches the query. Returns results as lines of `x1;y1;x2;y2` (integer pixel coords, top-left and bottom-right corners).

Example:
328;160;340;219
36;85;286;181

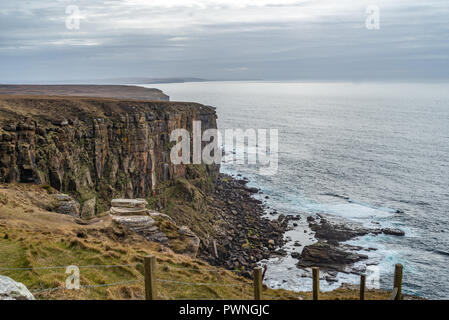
0;257;402;300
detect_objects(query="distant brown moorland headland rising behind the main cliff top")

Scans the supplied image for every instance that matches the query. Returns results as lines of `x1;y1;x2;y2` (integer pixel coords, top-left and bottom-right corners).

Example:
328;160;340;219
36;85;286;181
0;85;169;101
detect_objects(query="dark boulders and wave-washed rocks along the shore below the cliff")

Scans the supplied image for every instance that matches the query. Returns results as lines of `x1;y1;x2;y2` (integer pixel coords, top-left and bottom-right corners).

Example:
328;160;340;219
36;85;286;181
199;174;404;282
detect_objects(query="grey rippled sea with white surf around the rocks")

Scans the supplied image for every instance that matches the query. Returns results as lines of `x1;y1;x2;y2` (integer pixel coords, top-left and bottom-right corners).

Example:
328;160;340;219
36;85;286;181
144;81;449;299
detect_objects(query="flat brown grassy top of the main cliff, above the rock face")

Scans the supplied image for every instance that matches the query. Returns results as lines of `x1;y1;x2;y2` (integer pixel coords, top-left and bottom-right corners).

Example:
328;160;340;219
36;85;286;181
0;95;215;123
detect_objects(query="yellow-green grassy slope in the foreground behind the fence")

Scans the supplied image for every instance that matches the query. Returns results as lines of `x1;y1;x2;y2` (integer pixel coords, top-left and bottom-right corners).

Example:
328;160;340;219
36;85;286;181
0;184;402;299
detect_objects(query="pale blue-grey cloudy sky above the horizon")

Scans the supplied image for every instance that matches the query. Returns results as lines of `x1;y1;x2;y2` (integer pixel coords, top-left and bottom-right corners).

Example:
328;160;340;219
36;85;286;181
0;0;449;83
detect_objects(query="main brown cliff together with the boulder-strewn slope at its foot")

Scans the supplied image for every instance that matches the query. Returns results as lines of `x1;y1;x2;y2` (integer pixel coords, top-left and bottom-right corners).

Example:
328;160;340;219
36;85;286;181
0;96;288;277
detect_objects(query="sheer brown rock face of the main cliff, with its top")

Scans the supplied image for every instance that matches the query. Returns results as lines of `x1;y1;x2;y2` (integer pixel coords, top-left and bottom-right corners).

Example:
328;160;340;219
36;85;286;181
0;96;218;216
